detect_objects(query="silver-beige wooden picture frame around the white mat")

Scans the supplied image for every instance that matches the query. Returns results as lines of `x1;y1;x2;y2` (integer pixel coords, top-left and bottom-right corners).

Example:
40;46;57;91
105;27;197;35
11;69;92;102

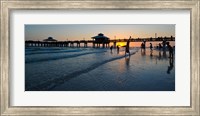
0;0;200;116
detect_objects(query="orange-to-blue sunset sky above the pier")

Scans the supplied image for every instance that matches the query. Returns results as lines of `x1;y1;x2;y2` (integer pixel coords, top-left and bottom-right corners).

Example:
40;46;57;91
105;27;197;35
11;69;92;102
25;24;175;41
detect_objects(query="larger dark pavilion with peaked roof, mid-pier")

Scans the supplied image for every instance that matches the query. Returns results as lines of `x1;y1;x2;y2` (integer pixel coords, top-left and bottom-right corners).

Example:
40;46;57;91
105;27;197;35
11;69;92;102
92;33;110;48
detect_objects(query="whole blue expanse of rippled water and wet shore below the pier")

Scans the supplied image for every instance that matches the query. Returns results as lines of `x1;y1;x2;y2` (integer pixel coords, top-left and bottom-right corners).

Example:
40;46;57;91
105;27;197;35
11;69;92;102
25;47;175;91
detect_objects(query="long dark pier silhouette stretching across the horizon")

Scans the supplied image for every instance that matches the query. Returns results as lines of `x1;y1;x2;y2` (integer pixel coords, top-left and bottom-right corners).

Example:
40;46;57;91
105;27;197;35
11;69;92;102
25;36;175;48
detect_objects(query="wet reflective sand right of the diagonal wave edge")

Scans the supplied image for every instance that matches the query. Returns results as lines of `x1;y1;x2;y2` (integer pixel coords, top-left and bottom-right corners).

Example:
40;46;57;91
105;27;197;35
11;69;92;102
53;49;175;91
